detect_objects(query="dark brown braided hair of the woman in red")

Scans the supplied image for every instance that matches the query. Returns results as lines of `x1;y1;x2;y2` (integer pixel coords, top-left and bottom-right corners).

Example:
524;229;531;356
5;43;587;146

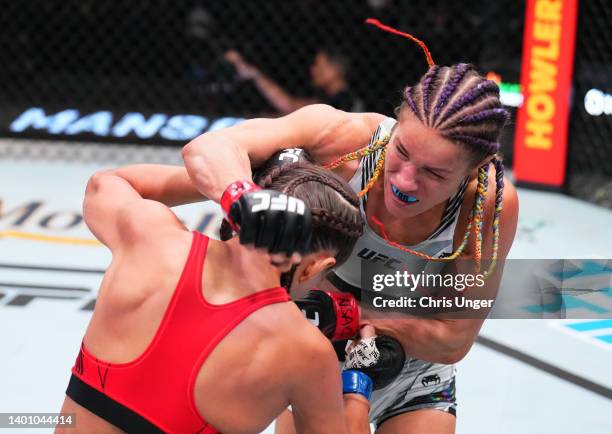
221;162;363;265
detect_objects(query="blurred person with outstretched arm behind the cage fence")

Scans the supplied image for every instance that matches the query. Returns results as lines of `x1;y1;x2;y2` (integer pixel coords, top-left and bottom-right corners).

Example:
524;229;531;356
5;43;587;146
225;48;364;114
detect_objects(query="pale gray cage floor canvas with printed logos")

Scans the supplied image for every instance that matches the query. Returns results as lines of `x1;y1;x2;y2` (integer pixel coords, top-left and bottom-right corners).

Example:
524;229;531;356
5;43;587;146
0;141;612;434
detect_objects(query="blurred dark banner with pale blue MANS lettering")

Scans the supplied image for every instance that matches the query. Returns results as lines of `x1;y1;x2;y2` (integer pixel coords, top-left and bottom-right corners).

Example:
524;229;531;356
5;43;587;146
0;106;244;145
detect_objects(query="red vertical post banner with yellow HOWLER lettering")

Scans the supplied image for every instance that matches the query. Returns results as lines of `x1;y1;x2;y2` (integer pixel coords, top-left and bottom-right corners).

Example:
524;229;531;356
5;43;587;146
514;0;578;188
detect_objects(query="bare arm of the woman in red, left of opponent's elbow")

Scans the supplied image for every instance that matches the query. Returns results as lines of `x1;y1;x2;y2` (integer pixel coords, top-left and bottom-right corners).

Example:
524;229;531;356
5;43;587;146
110;164;206;207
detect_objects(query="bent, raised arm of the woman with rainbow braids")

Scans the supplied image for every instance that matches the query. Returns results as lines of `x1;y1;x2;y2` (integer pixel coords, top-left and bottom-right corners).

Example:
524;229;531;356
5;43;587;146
183;104;382;202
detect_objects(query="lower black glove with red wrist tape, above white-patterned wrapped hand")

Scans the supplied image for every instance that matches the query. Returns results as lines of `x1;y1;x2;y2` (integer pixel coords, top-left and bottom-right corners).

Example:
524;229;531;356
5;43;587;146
295;289;359;341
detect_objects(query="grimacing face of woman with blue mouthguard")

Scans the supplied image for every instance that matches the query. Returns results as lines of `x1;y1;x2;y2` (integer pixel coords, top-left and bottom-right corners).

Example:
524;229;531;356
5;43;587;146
384;110;470;218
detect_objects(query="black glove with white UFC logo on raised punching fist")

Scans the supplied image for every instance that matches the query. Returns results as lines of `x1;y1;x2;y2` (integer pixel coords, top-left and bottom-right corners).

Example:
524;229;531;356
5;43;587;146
221;181;312;256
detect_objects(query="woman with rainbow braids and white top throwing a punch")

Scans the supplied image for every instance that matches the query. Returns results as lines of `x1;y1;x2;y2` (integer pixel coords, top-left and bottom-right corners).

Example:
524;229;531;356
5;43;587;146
183;23;518;434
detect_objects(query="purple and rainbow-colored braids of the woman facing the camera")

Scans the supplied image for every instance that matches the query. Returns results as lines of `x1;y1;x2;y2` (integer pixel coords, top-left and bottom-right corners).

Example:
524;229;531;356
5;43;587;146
326;19;510;276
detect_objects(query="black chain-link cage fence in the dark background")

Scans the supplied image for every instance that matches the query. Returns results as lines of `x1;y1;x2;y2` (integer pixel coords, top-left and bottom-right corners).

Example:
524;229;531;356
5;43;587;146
0;0;612;206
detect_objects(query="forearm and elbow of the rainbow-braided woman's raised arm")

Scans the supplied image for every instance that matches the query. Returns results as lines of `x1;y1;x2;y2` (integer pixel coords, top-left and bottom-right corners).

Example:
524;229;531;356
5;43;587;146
183;133;252;202
